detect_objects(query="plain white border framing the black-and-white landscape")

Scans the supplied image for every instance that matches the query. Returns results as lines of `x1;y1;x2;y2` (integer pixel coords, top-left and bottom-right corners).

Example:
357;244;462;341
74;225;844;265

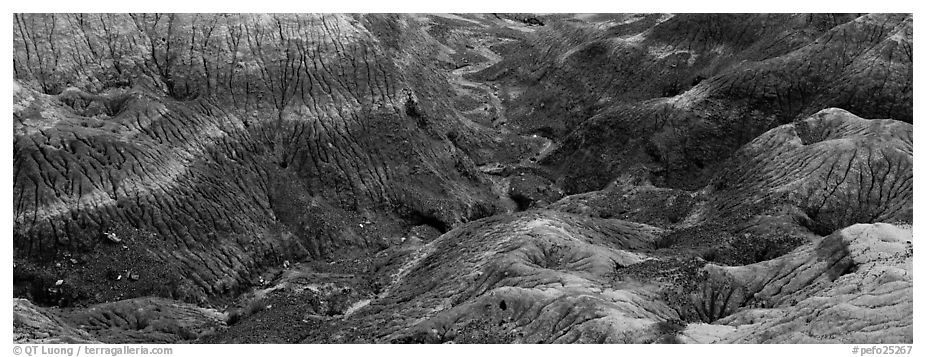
0;0;926;357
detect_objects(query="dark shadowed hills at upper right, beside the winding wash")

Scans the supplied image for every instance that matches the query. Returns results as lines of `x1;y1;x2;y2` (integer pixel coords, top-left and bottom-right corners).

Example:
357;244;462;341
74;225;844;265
477;14;913;193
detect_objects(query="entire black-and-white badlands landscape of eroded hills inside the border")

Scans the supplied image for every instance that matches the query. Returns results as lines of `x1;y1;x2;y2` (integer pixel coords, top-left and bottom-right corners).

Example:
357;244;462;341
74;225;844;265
12;14;913;343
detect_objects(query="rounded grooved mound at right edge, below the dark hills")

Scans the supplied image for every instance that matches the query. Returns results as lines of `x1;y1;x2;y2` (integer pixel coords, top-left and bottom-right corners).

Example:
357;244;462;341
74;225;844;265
707;109;913;235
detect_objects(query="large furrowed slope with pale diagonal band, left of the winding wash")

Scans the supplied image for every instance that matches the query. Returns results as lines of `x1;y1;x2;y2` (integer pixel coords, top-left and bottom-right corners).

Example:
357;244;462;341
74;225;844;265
13;14;508;303
